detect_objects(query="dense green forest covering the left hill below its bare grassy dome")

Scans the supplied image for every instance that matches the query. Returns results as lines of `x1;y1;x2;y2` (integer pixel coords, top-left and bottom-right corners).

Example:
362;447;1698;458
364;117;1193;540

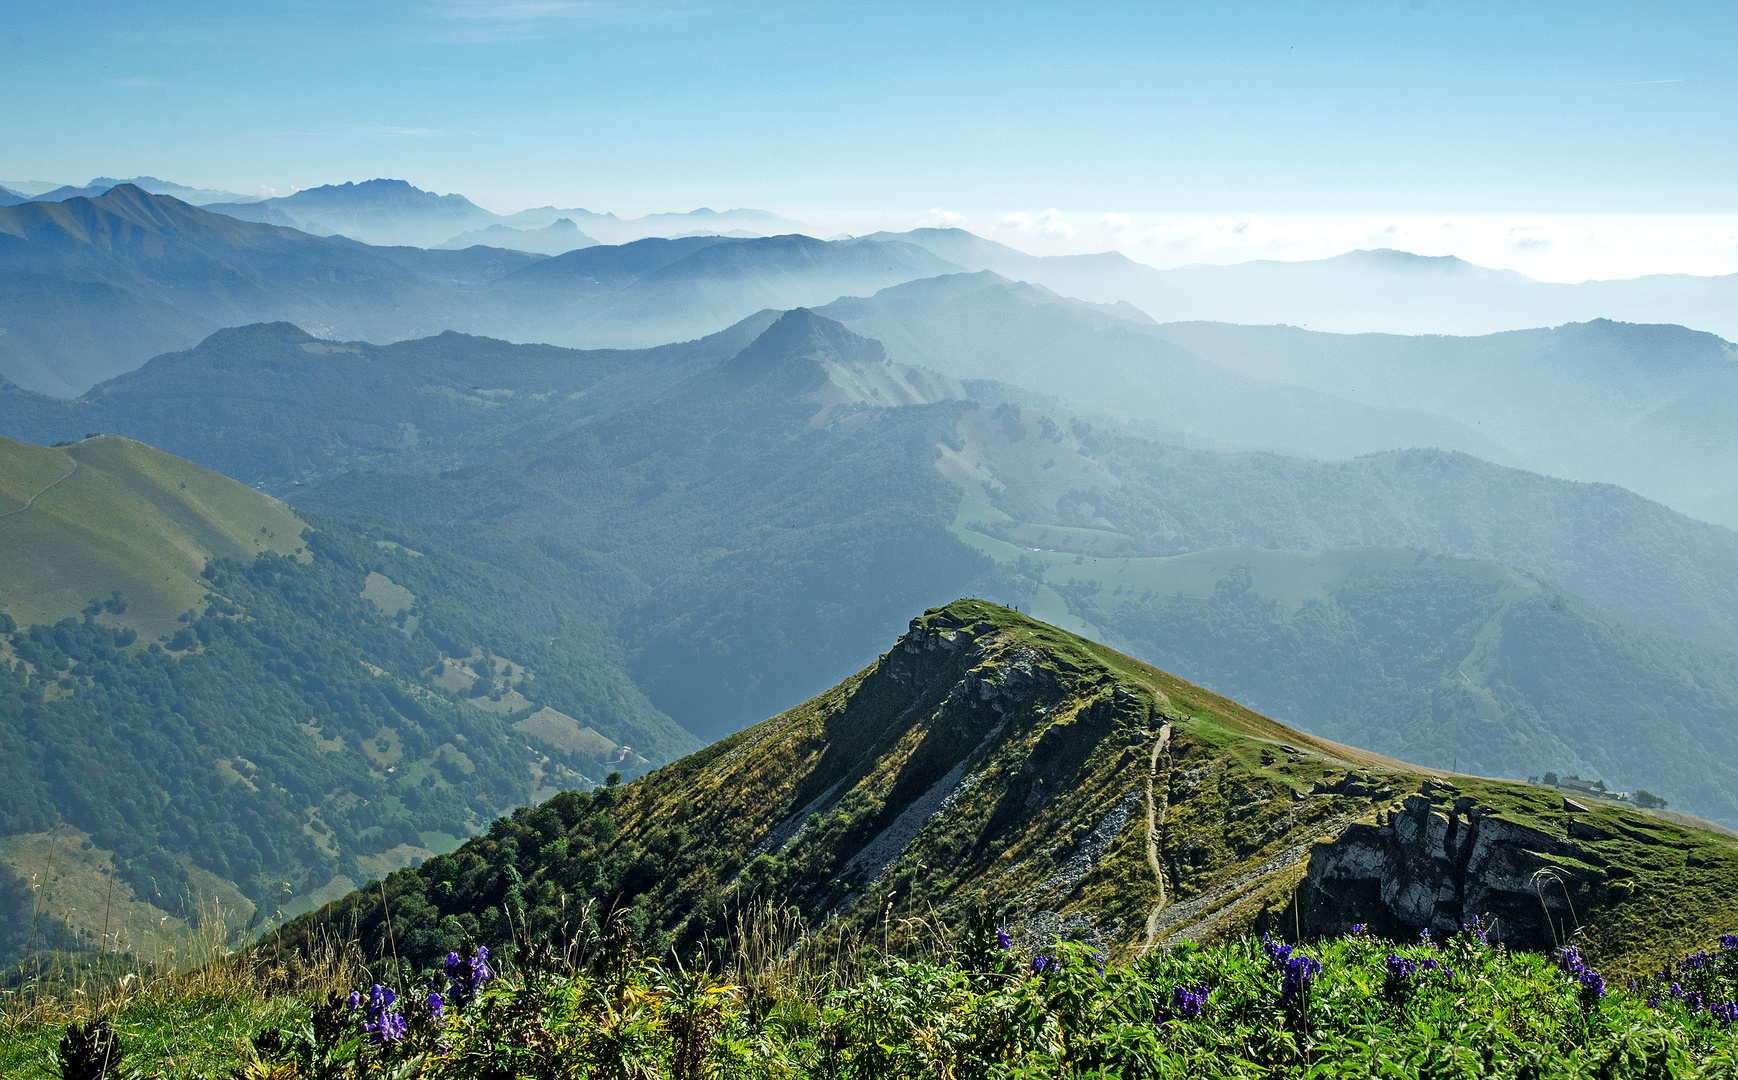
0;522;693;911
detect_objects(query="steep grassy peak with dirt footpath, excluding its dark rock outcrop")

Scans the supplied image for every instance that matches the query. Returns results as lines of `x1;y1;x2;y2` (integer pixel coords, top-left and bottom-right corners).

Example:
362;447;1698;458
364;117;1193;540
285;600;1738;970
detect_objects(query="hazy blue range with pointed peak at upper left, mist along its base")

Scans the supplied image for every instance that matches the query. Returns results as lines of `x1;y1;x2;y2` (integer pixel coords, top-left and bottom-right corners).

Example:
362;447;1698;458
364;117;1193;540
0;184;954;398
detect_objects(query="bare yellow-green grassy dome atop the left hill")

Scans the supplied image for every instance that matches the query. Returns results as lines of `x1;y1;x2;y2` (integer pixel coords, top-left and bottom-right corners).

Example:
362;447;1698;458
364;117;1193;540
0;435;304;640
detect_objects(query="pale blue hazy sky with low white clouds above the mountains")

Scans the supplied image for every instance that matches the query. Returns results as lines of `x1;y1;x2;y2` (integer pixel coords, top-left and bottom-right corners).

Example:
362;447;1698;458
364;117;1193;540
0;0;1738;278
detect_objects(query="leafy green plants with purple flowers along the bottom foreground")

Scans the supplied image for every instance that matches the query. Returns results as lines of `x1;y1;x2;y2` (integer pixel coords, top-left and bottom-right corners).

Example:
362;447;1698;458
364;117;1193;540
13;923;1738;1080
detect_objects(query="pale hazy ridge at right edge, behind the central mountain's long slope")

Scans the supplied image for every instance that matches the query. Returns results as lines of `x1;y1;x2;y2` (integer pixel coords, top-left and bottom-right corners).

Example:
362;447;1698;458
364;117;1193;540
1154;318;1738;525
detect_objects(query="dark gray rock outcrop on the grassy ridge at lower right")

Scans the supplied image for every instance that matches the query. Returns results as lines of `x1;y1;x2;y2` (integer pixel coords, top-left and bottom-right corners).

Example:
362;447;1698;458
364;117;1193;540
1298;784;1599;950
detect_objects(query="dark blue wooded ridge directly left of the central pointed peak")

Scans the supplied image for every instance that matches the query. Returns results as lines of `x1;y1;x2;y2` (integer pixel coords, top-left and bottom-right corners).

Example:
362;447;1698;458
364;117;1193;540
0;313;775;496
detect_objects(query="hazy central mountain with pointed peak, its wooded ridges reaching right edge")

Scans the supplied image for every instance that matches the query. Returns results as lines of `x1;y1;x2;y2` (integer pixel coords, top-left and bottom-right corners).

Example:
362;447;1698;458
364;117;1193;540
271;311;1738;821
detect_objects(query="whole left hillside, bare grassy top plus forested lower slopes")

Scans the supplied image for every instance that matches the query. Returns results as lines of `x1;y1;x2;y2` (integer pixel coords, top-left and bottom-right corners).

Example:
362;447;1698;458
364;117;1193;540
0;437;697;953
